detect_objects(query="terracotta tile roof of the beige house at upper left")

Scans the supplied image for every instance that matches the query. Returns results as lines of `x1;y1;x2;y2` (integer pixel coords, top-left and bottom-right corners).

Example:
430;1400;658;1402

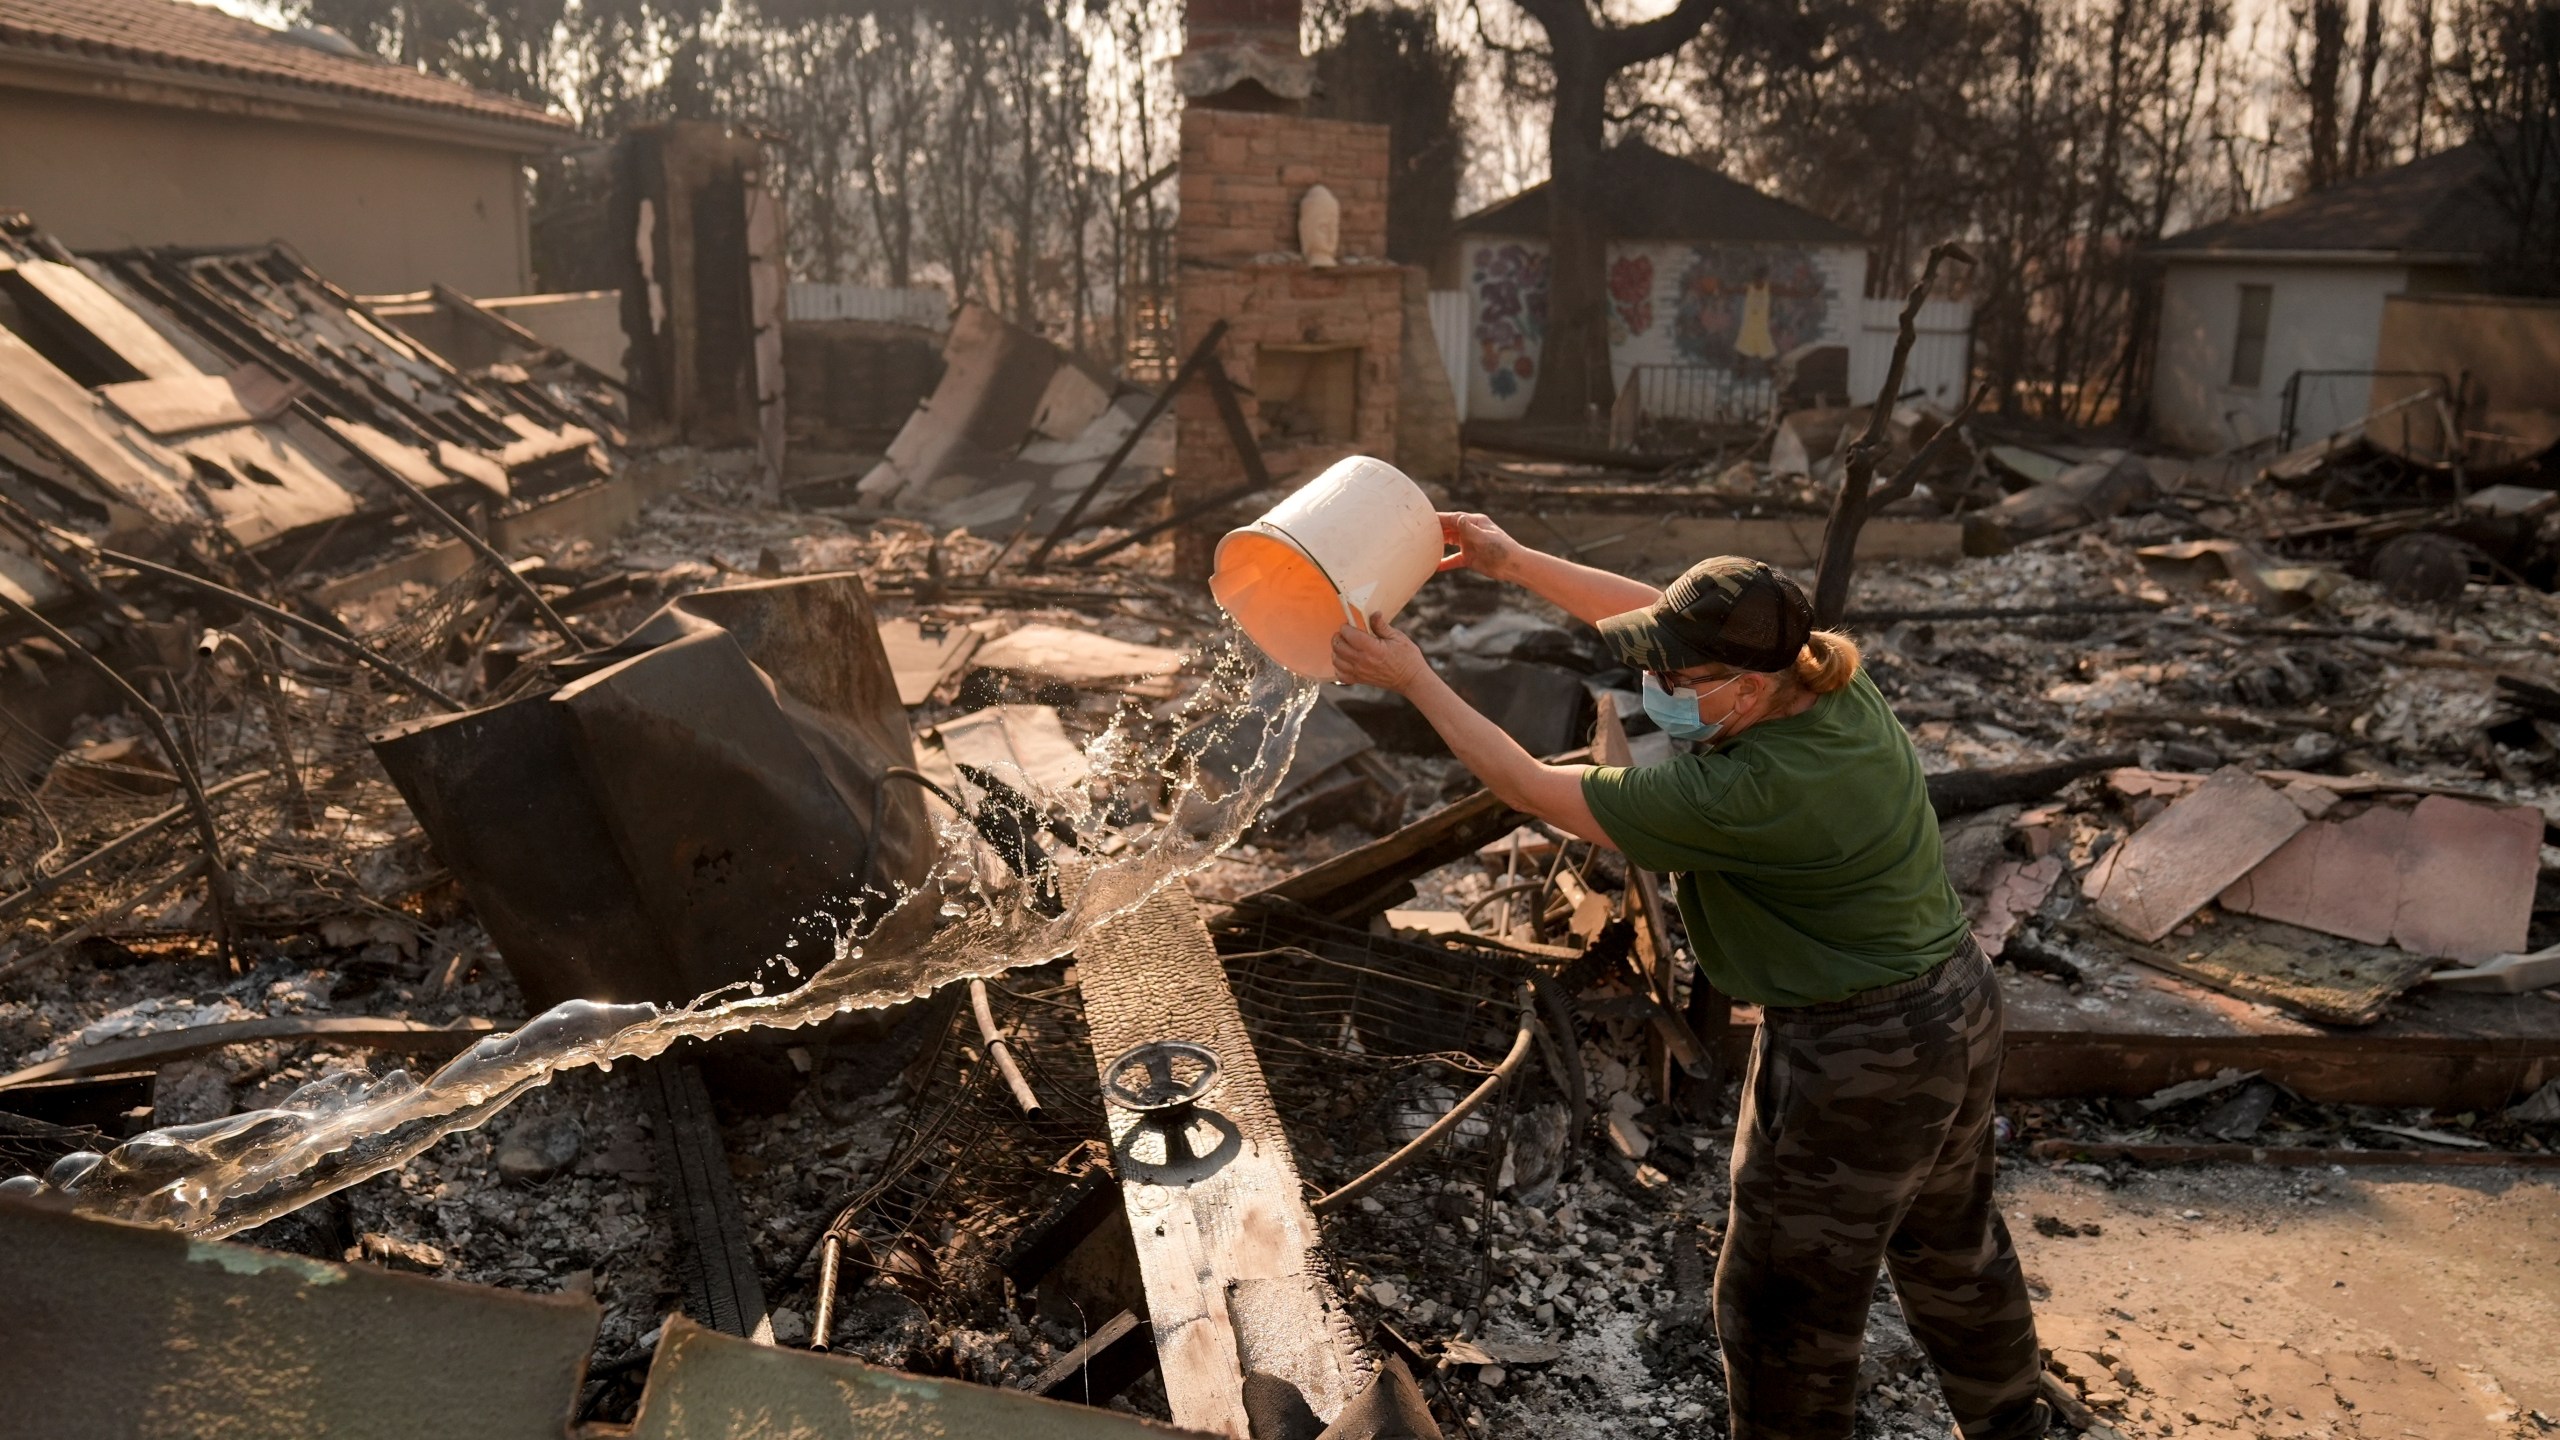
0;0;571;133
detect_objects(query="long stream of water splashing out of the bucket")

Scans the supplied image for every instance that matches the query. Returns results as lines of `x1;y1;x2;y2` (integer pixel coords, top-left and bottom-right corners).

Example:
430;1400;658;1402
42;633;1316;1238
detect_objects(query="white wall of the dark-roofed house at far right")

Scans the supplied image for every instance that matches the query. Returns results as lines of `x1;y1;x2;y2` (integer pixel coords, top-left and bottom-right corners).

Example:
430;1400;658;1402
2150;261;2409;451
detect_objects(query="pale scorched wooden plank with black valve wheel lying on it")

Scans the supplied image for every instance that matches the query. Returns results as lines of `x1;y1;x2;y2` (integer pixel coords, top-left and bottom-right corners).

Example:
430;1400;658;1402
1075;887;1359;1440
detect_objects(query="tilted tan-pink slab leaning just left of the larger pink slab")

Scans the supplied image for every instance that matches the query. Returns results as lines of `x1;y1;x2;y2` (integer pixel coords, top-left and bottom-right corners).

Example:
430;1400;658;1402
2081;766;2309;940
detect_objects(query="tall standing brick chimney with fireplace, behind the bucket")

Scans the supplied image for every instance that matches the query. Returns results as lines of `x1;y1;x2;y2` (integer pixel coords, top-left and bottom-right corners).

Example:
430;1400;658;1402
1172;0;1405;577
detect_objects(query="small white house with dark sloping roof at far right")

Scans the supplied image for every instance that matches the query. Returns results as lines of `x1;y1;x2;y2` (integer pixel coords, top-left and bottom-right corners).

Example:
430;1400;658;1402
2150;143;2511;451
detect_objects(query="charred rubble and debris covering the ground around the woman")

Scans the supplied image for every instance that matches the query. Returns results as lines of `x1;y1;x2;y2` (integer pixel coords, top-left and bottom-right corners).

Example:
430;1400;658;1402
0;210;2560;1437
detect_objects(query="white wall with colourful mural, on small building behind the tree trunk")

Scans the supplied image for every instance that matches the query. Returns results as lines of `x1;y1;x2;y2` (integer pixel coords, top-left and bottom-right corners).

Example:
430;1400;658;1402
1464;238;1866;420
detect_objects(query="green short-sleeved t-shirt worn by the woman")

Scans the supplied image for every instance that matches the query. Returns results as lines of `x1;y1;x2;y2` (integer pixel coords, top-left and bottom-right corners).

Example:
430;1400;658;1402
1582;671;1966;1004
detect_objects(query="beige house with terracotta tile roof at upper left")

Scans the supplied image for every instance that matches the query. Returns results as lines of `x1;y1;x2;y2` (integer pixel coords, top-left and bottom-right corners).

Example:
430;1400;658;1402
0;0;579;297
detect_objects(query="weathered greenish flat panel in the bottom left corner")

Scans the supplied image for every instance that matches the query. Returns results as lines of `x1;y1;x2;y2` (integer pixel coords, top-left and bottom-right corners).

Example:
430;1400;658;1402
0;1202;602;1440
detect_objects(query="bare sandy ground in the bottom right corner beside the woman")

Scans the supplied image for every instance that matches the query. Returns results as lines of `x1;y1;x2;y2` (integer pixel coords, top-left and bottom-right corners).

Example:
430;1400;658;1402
2002;1168;2560;1440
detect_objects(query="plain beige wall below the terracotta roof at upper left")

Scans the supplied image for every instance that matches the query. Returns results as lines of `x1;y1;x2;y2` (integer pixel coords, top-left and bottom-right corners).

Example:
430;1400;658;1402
0;87;532;295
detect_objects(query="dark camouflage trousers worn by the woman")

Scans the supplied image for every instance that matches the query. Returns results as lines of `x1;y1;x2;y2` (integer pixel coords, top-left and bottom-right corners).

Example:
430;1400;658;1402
1715;940;2045;1440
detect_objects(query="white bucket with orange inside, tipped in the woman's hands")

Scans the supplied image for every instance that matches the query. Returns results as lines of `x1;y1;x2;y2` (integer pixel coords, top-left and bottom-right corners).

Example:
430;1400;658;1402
1208;456;1441;679
